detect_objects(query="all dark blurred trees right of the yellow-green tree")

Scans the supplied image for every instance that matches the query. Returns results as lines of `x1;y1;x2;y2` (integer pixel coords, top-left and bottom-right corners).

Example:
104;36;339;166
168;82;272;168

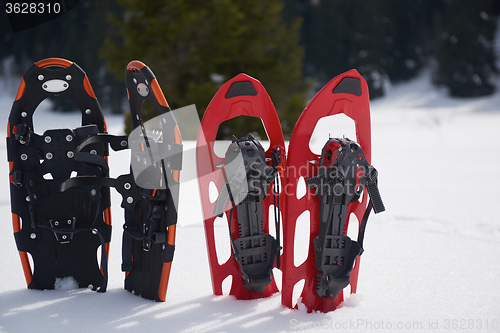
286;0;500;98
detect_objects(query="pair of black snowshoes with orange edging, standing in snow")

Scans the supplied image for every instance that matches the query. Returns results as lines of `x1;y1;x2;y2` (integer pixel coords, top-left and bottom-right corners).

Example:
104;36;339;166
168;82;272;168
7;58;182;301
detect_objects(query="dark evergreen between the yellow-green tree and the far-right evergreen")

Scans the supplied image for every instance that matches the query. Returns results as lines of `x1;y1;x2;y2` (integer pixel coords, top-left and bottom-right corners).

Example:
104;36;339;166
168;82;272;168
287;0;425;98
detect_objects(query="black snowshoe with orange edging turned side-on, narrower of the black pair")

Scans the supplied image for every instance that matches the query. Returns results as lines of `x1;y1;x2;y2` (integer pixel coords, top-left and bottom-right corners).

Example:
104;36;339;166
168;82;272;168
116;60;182;301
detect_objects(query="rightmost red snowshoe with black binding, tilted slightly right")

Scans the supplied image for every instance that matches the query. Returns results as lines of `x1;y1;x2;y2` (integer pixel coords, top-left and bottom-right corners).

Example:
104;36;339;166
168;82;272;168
282;70;385;312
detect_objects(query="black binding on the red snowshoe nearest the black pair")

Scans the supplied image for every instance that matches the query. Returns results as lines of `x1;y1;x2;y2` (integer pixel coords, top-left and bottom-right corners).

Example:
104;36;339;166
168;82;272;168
214;134;281;292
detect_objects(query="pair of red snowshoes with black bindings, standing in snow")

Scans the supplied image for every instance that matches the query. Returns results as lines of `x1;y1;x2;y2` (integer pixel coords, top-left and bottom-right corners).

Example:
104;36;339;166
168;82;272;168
197;70;385;312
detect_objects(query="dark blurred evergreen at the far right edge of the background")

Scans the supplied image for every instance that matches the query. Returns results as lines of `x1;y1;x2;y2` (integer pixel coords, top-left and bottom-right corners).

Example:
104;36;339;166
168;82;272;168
433;0;499;97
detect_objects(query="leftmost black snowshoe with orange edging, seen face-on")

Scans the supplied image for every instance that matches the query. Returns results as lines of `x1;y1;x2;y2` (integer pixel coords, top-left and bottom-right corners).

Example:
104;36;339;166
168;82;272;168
7;58;127;292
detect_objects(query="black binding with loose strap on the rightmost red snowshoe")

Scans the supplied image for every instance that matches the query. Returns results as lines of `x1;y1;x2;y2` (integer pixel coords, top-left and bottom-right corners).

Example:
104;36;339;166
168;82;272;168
306;138;385;298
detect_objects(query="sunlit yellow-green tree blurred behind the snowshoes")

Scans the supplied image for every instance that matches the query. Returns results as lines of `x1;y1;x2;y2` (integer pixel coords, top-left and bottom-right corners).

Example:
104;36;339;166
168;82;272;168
102;0;307;136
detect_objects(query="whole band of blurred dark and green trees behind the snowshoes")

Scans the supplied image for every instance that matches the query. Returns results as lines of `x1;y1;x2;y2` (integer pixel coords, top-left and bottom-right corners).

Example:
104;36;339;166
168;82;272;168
0;0;500;132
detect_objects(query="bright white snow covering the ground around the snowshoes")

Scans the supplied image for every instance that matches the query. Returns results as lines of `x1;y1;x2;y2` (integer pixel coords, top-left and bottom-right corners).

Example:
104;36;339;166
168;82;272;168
0;74;500;332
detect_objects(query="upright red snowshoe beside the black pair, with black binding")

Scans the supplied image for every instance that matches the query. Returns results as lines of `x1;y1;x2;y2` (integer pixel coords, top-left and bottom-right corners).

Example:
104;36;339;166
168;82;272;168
196;74;285;299
